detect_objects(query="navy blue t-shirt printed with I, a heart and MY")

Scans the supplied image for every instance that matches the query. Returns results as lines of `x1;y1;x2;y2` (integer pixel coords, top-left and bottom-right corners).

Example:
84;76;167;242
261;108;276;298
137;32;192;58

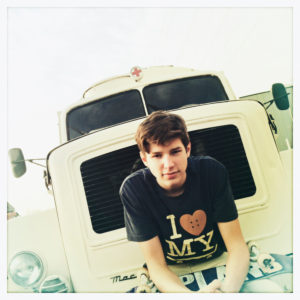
120;156;238;264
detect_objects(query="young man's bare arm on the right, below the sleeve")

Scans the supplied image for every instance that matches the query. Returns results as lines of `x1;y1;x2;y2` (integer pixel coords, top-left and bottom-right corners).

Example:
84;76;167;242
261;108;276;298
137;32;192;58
218;219;249;293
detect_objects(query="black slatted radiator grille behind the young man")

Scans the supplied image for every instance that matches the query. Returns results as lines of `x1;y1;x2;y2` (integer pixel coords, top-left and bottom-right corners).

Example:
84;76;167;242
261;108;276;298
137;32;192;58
80;125;256;233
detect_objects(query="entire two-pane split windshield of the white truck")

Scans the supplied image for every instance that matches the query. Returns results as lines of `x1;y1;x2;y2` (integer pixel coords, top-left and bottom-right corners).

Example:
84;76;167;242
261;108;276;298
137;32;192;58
67;75;228;140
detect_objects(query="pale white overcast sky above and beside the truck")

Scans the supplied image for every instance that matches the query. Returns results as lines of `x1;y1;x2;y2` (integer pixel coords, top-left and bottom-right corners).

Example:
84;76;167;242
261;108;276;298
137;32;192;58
2;7;293;215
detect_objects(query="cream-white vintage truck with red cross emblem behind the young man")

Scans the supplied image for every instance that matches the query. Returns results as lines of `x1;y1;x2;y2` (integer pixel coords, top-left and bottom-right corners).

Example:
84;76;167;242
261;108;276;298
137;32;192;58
8;66;293;293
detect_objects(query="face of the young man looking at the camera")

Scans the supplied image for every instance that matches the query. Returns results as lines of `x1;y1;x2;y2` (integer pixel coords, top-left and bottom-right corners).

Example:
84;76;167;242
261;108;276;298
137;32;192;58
140;138;191;197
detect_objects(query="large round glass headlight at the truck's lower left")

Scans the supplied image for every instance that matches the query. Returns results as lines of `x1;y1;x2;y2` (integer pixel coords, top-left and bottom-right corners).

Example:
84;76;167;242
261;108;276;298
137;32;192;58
8;251;44;288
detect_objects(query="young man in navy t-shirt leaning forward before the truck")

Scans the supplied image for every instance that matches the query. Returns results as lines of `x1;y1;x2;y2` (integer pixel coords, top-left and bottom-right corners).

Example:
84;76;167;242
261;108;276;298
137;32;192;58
120;111;249;292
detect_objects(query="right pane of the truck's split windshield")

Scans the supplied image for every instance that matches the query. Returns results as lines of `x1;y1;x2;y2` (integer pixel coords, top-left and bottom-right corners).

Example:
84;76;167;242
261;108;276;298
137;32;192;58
143;75;228;114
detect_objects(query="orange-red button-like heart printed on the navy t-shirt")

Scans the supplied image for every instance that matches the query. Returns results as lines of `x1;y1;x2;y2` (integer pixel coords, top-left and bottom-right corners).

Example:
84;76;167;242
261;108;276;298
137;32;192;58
180;209;206;236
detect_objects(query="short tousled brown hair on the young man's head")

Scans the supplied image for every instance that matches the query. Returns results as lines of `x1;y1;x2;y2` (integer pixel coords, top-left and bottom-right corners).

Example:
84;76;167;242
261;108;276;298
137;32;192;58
135;110;190;153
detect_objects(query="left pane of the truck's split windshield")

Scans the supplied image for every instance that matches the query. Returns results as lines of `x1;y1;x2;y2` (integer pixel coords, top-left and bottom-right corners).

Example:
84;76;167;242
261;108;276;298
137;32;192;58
67;90;145;140
